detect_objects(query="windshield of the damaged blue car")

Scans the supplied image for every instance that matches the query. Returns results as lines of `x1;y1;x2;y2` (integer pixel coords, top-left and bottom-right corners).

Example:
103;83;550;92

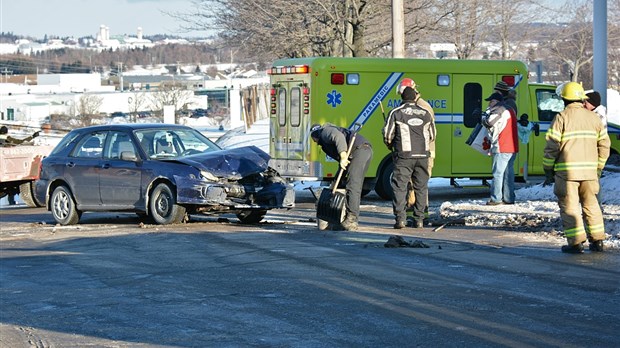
135;128;220;159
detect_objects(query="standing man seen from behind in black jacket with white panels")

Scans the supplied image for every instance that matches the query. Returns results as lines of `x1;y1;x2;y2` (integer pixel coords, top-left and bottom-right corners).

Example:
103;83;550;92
383;87;436;229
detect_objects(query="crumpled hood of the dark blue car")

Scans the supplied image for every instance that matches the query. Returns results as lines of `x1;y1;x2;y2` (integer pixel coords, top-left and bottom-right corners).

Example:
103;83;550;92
175;146;271;180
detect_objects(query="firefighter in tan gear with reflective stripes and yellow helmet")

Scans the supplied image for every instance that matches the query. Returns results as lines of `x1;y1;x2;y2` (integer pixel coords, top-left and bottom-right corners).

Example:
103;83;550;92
543;82;611;254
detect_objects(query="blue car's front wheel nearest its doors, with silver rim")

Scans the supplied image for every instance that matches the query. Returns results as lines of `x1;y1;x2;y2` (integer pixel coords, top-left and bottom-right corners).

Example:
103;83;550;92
149;184;185;225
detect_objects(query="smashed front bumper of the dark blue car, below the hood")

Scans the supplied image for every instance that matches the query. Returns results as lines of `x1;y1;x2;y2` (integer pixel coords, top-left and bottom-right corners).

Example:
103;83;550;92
174;175;295;210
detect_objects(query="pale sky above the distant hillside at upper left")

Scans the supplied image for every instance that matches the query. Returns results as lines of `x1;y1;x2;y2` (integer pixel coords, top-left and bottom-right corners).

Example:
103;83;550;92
0;0;207;39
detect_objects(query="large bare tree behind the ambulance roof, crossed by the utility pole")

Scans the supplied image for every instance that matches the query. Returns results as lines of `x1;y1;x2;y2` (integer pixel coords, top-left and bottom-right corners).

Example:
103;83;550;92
173;0;445;61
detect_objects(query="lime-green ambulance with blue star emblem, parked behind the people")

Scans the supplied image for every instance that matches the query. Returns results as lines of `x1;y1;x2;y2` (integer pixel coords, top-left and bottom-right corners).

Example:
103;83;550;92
269;57;620;199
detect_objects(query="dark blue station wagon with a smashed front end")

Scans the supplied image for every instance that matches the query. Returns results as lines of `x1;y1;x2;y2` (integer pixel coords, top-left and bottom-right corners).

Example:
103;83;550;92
35;124;295;225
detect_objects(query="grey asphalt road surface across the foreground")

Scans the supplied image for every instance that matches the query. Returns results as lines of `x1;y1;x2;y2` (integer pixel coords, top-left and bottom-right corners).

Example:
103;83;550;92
0;189;620;348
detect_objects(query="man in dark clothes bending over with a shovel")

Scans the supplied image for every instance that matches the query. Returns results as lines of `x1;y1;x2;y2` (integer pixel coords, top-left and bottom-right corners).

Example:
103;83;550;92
310;123;372;231
